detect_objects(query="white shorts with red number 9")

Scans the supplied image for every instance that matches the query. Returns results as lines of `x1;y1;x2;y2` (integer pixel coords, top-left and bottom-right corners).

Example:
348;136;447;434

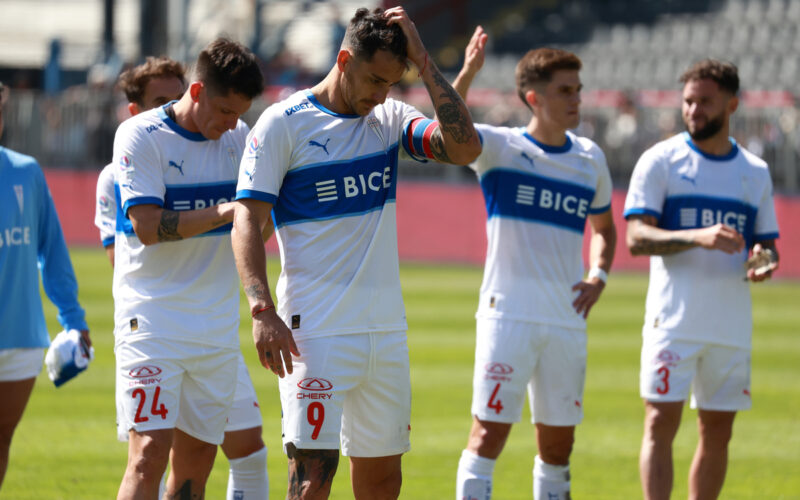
279;332;411;457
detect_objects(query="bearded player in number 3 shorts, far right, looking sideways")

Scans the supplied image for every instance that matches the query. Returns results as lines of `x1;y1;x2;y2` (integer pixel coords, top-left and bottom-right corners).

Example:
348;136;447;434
625;60;778;499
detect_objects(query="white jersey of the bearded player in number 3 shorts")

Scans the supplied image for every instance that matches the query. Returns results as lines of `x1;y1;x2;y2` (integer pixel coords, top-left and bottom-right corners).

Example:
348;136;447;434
625;133;778;348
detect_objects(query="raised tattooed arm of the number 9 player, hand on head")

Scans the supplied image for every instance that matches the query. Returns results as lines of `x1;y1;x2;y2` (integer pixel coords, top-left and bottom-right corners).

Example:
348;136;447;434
384;7;481;165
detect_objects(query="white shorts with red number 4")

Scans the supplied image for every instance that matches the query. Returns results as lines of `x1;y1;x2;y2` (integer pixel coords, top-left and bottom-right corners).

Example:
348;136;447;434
472;318;586;426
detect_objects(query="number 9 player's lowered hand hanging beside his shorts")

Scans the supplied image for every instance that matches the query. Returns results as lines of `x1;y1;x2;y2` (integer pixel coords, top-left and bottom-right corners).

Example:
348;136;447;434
253;309;300;378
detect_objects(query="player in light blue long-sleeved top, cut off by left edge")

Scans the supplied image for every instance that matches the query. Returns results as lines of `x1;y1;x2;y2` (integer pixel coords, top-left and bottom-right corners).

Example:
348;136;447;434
0;83;91;486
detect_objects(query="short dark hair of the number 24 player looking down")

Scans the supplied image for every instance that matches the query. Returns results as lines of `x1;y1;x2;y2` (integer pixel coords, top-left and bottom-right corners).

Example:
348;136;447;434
194;38;264;99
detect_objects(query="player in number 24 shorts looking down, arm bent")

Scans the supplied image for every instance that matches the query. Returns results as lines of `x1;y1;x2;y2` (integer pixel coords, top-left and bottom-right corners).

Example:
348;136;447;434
114;39;263;498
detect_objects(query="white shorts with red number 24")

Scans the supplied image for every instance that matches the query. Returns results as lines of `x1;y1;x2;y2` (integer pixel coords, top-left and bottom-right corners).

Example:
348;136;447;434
114;338;241;444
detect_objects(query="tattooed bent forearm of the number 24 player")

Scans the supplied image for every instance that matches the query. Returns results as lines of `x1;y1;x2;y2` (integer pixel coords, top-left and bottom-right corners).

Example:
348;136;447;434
128;202;234;245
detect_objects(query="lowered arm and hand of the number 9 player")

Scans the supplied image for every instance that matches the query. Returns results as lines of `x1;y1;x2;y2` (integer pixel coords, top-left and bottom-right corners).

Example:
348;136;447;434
231;198;300;377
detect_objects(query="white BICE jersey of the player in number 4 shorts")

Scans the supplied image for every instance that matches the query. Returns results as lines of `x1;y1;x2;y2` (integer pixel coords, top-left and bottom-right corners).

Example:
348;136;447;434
471;125;611;329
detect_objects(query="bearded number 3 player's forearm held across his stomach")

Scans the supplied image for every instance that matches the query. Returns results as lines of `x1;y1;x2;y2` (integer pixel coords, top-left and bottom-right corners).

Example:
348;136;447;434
625;215;744;255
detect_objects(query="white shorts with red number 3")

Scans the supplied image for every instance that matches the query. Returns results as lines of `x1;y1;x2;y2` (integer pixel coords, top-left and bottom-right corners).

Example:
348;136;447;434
639;336;752;411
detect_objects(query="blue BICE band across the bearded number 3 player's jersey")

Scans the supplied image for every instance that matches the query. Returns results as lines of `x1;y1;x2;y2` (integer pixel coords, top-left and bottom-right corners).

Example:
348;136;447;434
658;196;758;246
